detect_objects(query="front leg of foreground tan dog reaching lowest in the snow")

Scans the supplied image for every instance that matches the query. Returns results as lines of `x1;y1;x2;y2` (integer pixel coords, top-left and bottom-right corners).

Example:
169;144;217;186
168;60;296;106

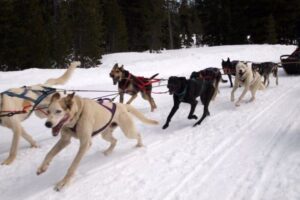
54;136;91;191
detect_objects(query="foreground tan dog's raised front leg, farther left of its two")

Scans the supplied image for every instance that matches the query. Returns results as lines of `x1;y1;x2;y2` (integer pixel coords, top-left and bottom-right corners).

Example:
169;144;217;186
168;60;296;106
36;134;71;175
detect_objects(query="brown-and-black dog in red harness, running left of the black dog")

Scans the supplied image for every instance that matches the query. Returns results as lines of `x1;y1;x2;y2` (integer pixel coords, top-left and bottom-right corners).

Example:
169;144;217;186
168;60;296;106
109;63;158;112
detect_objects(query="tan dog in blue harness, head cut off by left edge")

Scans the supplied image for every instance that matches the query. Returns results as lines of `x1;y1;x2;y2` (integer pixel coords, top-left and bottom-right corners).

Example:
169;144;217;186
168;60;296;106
0;62;80;165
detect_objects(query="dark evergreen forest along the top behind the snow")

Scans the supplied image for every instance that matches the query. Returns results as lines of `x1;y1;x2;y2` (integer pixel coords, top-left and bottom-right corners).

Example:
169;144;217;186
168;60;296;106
0;0;300;71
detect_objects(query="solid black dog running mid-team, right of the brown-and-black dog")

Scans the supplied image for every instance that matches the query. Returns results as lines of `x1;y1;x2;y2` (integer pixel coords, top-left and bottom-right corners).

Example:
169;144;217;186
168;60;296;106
163;76;216;129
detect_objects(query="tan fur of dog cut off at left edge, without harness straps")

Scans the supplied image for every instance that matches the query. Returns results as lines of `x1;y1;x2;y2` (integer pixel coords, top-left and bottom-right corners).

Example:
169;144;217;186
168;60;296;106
0;62;80;165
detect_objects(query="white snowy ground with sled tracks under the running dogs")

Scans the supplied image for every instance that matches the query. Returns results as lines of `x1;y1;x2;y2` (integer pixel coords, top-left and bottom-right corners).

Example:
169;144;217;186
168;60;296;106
0;45;300;200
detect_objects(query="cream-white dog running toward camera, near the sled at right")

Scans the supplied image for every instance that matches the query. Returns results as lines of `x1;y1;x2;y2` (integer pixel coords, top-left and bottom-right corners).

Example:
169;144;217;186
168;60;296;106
231;62;265;106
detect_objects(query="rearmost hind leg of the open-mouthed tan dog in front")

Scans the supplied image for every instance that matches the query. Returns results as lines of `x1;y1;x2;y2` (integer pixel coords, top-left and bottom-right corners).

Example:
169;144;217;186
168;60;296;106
119;113;143;147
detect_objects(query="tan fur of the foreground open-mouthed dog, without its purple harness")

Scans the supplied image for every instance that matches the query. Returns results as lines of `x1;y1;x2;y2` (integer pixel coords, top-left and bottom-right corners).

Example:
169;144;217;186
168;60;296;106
37;93;158;191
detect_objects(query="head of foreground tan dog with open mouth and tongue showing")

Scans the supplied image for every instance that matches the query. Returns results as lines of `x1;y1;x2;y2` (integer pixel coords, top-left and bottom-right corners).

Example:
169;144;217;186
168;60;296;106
45;93;75;136
